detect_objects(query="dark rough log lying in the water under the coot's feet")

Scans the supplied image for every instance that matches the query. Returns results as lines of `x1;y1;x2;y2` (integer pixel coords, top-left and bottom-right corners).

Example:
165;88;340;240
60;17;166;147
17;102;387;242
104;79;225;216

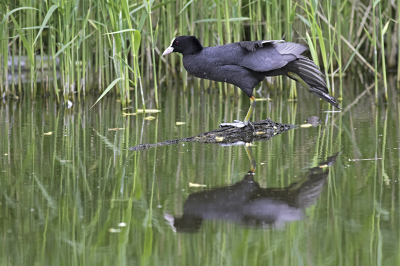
129;119;297;151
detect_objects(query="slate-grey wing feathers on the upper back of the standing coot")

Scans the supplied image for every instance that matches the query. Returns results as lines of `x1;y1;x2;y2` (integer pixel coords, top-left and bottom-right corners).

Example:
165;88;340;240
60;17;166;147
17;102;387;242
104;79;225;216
239;41;307;72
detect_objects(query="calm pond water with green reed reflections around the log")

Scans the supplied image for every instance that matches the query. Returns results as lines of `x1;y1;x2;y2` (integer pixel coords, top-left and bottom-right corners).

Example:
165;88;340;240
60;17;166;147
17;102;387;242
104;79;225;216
0;77;400;265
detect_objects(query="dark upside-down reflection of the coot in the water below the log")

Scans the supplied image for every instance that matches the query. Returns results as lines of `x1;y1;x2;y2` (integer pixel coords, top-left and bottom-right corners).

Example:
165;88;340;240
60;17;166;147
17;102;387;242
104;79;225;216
168;155;337;232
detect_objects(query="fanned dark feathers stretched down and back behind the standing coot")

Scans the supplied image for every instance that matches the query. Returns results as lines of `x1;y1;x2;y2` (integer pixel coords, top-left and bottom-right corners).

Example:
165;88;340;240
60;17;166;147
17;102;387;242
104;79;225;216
285;56;341;109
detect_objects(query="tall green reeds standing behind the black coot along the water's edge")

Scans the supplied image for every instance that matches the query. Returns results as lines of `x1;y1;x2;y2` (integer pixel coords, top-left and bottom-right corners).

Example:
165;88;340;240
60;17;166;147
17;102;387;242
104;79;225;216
0;0;400;109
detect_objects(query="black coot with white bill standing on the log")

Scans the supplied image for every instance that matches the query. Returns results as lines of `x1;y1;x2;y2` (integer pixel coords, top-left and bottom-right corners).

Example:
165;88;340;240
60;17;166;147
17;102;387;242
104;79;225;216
163;36;340;129
